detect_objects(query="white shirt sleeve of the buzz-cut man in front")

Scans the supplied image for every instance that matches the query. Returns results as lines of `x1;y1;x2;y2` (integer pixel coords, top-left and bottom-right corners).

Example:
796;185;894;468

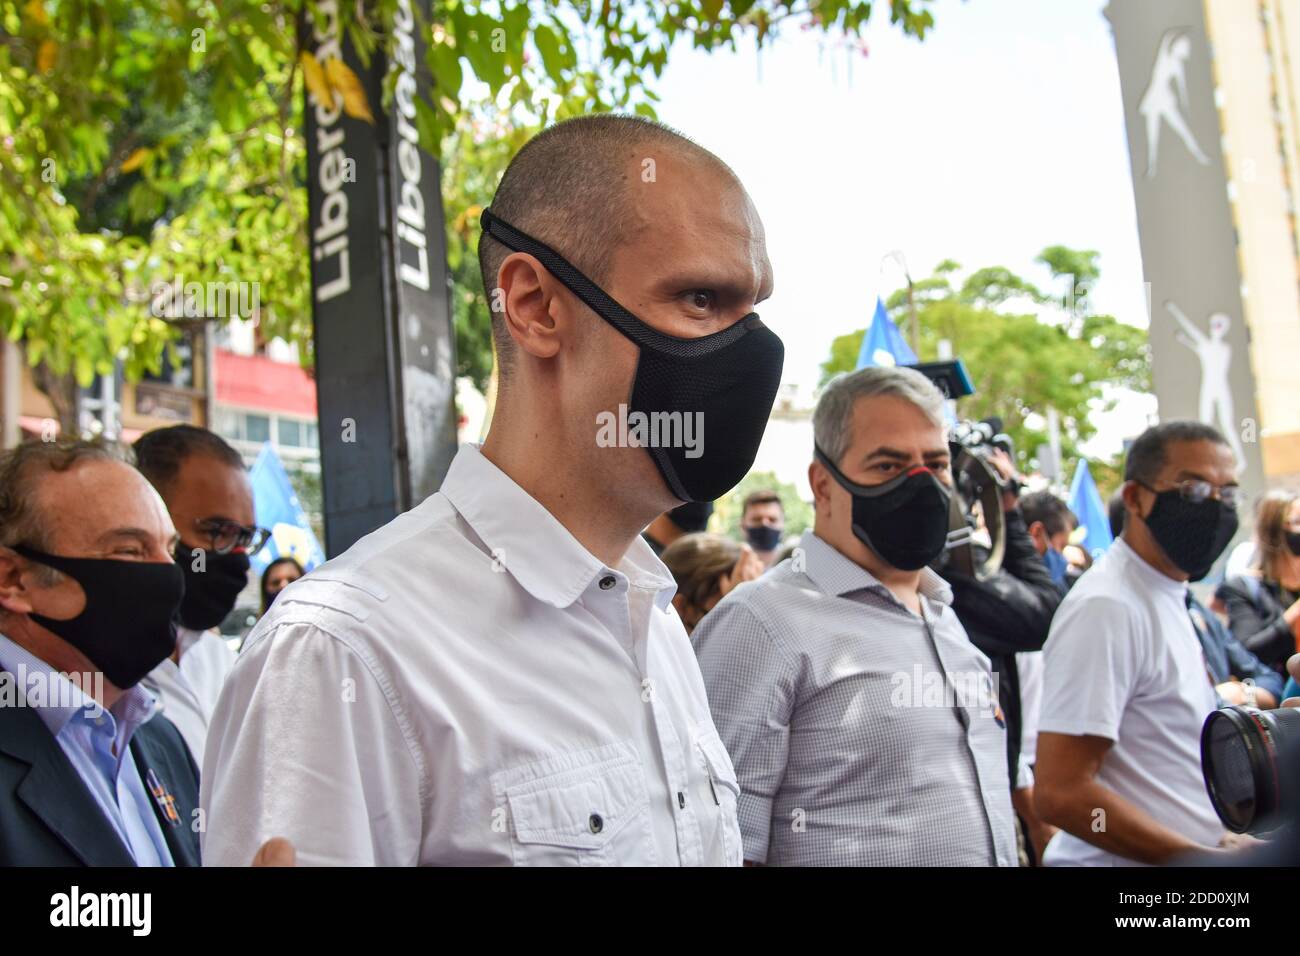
200;623;424;866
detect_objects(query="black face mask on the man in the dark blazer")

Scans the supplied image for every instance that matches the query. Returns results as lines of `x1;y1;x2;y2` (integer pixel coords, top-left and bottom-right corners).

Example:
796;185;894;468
13;545;185;689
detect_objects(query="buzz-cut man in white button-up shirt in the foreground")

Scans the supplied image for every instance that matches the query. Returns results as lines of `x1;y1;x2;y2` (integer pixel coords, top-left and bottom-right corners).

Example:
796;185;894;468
202;116;781;865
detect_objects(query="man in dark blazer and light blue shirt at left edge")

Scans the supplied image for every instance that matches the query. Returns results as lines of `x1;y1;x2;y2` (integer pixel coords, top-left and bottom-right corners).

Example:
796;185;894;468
0;442;199;866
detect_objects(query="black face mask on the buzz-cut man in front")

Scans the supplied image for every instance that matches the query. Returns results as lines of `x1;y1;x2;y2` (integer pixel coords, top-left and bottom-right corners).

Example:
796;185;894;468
480;209;785;501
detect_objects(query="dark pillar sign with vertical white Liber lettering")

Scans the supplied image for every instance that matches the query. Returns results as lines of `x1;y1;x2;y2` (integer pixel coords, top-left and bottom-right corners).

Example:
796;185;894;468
299;0;456;554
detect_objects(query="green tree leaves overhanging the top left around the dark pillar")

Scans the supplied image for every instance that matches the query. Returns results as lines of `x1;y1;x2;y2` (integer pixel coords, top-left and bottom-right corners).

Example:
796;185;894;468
0;0;951;403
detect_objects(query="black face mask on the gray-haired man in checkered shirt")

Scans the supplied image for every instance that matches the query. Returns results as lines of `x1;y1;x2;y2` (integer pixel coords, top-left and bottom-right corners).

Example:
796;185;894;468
814;449;952;571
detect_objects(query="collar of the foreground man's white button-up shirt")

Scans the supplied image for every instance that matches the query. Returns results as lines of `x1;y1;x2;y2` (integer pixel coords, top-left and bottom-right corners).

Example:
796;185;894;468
442;445;677;609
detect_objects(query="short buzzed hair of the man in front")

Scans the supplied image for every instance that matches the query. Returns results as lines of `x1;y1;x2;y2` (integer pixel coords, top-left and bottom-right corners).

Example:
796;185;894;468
478;113;735;376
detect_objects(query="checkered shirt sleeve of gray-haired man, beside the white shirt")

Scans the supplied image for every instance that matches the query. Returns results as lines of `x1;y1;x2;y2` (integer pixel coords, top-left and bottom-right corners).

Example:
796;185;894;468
694;600;796;862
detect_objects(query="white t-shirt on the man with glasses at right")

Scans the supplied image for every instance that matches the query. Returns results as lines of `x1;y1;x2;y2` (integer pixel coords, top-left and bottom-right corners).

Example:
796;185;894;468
1039;540;1223;866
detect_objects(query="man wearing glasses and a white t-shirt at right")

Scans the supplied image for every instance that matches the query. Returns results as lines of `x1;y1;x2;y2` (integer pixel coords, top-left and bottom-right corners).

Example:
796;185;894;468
1035;421;1240;866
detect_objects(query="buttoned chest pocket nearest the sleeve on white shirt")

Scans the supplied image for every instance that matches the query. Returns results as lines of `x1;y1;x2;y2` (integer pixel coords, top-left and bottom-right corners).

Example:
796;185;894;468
493;744;658;866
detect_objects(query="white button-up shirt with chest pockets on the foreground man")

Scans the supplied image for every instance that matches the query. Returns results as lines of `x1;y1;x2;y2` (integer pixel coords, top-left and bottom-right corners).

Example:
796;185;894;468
202;446;741;866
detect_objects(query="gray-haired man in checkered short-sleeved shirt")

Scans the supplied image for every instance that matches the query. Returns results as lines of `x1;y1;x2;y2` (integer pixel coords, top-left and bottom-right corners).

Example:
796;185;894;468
694;368;1017;866
